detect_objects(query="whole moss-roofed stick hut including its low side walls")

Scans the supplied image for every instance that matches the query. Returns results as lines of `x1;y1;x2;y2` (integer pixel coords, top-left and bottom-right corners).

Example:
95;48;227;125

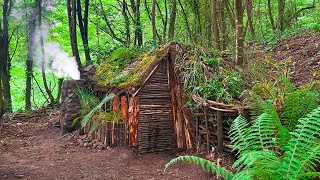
61;43;247;153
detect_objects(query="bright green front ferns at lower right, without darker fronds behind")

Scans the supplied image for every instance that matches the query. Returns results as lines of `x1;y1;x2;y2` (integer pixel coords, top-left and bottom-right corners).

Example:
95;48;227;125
165;106;320;180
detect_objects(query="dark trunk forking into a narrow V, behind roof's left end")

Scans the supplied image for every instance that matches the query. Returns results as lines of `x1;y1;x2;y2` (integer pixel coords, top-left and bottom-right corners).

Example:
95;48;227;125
77;0;92;65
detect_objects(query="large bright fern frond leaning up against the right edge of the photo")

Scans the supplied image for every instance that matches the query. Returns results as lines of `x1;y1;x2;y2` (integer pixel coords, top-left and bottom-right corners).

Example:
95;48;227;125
281;107;320;179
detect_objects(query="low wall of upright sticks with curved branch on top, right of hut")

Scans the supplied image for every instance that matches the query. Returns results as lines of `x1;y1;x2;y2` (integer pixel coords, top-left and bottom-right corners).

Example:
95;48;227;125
192;95;250;153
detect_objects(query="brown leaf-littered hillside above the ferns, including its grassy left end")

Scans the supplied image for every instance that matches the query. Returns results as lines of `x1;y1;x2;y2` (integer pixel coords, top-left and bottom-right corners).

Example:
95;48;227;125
246;31;320;86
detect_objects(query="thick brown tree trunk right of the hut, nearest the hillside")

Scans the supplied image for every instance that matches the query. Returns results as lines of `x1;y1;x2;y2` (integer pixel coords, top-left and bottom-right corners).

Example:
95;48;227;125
234;0;243;66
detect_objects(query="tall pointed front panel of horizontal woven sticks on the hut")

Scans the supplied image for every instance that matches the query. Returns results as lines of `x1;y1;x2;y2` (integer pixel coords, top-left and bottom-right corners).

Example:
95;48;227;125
137;60;175;153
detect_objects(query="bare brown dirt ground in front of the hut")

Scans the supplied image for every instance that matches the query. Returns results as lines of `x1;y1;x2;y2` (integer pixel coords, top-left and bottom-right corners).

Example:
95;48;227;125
0;112;230;180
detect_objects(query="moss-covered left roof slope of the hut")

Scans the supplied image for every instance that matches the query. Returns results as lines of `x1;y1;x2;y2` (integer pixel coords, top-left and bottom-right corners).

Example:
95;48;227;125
96;46;167;88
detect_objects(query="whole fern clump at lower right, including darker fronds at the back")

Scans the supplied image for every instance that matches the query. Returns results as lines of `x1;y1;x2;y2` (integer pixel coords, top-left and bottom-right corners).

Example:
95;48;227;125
165;81;320;180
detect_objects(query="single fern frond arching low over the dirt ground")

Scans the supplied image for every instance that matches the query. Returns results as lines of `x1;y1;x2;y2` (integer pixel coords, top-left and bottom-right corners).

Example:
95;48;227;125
165;156;234;180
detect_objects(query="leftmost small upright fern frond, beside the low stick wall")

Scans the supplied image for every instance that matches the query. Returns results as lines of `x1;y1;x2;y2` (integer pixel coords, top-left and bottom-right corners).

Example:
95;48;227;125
229;115;249;153
